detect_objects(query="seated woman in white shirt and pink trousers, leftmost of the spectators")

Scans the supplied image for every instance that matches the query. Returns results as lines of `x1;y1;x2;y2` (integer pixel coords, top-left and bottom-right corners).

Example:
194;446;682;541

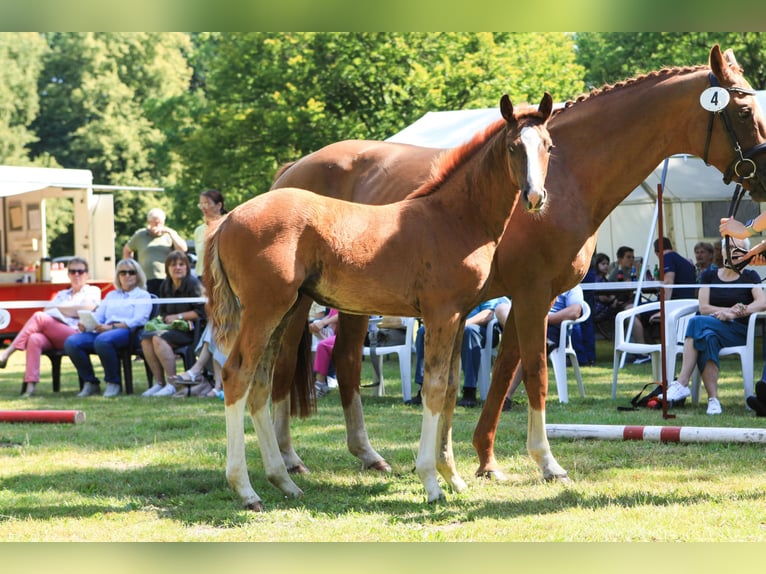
0;257;101;397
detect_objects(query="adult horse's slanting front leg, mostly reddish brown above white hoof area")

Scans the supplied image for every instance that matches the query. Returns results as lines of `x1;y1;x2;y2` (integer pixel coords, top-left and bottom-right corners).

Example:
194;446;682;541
473;307;519;481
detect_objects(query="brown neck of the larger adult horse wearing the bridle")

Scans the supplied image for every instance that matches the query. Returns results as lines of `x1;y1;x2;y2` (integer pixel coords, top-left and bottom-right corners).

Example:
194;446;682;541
548;68;705;228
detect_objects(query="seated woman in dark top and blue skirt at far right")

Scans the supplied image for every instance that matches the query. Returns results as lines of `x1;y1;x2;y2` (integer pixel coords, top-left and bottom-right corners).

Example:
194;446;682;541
667;238;766;415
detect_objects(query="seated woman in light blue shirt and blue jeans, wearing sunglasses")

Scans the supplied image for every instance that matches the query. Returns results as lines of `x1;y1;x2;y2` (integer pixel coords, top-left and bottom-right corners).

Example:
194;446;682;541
64;259;152;397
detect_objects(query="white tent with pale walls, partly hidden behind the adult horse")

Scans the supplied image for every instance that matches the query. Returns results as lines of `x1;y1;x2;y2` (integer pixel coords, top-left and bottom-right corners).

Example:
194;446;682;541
386;91;766;275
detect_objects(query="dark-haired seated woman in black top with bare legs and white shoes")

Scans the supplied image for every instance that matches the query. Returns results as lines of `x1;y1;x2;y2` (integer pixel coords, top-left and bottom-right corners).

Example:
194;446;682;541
141;251;205;397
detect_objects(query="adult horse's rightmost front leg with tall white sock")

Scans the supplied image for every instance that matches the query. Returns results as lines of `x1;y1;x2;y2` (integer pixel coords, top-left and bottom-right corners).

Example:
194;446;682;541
515;291;569;481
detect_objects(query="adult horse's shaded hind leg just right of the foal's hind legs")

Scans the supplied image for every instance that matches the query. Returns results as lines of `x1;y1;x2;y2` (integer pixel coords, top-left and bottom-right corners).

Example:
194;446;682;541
271;295;313;474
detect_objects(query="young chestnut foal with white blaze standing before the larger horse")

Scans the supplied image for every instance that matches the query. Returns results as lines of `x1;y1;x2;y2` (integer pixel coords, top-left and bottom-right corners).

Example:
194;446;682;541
205;93;553;510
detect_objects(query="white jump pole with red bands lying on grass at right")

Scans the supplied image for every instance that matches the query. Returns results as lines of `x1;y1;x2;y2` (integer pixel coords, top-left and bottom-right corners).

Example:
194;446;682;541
545;424;766;443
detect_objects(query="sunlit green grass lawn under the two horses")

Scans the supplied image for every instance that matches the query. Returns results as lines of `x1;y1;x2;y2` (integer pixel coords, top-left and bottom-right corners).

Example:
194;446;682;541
0;342;766;542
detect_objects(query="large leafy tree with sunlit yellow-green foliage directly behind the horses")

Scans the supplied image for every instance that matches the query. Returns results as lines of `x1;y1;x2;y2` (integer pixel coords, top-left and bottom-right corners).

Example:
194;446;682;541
173;33;583;222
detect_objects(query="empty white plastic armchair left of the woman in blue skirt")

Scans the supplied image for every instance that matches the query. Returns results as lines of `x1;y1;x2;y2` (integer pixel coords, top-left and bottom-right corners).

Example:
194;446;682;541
612;299;699;399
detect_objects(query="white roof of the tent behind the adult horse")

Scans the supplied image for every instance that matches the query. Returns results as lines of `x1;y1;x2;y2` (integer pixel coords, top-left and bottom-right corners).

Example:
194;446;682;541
386;94;766;209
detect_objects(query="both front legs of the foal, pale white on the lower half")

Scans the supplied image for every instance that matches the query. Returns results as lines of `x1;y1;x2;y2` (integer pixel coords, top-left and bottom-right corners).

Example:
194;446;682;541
415;315;465;502
